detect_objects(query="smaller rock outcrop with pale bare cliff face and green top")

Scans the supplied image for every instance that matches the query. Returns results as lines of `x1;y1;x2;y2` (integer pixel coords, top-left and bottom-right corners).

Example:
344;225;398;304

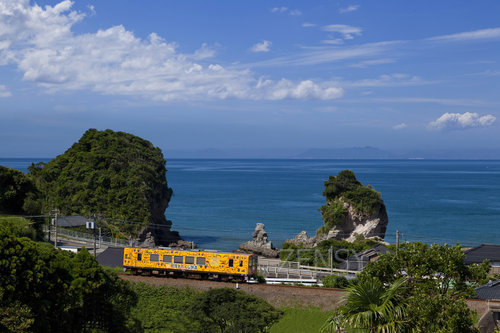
287;170;389;247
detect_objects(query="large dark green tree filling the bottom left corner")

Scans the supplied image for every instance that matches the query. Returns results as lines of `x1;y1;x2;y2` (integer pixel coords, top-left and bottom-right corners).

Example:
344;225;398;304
0;217;135;332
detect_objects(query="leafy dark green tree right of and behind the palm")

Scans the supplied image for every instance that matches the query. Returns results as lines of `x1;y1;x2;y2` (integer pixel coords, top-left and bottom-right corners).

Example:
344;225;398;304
358;242;489;333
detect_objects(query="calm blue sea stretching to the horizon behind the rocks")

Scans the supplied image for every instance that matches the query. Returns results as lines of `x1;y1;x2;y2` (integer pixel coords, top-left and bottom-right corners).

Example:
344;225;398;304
0;158;500;250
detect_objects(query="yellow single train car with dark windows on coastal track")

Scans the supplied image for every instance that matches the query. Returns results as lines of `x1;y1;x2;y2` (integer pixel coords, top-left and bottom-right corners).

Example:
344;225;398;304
123;247;258;280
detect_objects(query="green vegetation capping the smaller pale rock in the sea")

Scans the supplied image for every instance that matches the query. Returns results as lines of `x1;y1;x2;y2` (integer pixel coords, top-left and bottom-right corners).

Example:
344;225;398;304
317;170;383;234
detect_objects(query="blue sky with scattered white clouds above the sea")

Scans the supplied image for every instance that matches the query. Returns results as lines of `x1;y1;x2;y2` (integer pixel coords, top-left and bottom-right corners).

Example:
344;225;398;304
0;0;500;159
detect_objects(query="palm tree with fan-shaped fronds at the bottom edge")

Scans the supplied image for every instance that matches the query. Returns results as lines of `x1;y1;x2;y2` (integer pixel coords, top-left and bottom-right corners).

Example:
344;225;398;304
321;278;409;333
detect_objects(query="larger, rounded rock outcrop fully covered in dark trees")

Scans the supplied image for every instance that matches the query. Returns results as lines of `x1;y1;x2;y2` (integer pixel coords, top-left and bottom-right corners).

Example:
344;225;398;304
29;129;180;245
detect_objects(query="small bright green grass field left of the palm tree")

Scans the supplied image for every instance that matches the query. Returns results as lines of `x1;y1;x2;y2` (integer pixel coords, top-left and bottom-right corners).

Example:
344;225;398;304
269;306;332;333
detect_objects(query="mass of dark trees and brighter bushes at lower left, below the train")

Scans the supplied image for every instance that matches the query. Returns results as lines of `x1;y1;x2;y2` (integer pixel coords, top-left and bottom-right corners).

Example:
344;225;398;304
0;218;281;333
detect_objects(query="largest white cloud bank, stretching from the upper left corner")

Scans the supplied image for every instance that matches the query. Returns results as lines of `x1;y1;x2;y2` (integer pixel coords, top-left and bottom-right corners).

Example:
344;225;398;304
0;0;343;101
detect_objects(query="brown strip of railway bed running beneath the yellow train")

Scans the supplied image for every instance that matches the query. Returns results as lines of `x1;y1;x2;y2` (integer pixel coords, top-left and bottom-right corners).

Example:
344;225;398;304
119;274;345;310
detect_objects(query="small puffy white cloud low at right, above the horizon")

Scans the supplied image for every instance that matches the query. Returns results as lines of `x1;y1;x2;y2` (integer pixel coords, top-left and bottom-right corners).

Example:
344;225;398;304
428;112;496;130
